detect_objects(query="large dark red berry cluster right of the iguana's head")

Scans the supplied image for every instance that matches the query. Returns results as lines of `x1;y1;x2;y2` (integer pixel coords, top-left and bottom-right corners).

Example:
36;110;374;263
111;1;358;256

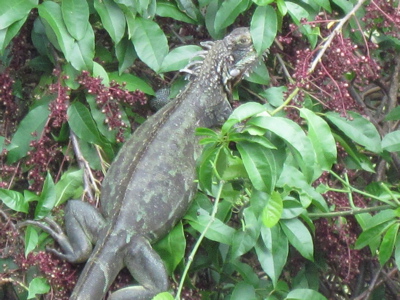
280;16;380;113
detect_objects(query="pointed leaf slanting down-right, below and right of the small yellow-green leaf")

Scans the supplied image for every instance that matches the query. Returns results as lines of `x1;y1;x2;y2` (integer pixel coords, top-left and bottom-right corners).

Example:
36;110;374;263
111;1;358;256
279;219;314;261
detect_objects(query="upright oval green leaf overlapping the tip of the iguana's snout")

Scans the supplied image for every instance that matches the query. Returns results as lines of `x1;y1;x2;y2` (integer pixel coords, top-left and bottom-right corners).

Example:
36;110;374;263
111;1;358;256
250;5;278;55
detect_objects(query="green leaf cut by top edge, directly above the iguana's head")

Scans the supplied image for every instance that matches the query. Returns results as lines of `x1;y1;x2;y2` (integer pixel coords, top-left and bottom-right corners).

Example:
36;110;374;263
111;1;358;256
214;0;249;31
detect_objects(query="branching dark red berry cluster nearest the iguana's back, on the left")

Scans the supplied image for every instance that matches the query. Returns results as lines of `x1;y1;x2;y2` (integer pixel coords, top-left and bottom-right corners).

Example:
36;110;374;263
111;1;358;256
78;71;147;142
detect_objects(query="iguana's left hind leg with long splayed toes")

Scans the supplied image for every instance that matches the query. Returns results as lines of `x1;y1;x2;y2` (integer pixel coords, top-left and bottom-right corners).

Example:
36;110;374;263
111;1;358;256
19;200;105;263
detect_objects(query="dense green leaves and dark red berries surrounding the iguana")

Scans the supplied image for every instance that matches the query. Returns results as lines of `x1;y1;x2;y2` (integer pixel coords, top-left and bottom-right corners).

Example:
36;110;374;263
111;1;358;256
0;0;400;300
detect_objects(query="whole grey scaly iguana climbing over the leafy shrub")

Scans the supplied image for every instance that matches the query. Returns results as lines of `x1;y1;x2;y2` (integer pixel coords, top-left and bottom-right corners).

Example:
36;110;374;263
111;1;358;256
23;28;256;300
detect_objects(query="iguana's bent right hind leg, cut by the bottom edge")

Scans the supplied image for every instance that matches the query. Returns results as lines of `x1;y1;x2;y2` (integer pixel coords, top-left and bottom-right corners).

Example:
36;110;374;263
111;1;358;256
109;236;169;300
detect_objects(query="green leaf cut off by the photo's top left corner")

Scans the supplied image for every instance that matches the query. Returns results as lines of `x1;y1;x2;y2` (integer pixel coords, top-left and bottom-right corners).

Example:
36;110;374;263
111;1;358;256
0;0;39;30
